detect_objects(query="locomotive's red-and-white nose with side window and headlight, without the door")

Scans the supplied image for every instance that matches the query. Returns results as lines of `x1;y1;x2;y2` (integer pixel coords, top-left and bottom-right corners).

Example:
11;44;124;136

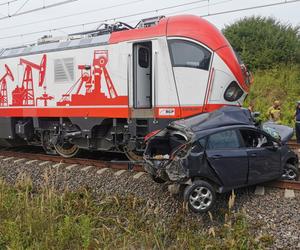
167;16;251;114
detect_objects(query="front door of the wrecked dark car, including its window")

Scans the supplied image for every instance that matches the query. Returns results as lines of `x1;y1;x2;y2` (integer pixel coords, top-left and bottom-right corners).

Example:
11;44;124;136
240;129;281;184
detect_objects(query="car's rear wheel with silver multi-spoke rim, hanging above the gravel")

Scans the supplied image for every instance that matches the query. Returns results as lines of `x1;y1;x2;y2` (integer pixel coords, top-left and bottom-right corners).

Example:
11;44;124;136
183;180;216;213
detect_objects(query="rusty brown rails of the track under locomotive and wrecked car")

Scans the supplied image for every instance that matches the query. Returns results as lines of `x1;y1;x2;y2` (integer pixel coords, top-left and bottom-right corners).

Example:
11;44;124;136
0;146;300;191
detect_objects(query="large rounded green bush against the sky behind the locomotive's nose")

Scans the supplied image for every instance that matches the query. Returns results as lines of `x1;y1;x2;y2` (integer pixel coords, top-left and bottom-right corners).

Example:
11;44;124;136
223;16;300;70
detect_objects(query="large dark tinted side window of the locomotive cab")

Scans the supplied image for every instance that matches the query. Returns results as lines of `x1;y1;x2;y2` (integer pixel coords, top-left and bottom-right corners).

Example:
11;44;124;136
168;39;211;70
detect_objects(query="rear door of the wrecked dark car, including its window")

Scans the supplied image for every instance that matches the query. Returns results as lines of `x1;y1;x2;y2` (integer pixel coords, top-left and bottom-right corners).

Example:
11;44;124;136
206;129;248;188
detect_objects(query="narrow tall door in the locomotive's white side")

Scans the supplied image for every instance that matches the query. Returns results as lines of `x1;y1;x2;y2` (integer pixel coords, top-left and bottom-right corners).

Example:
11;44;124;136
133;42;152;113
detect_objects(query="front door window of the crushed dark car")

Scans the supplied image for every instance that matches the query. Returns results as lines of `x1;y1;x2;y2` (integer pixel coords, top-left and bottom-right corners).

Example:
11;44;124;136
241;129;273;148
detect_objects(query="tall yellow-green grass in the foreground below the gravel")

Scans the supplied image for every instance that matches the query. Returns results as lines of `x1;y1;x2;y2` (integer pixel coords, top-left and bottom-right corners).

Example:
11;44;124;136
0;175;272;249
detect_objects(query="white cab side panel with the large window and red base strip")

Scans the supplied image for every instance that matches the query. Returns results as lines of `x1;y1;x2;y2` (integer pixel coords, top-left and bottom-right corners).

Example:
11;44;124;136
168;37;213;116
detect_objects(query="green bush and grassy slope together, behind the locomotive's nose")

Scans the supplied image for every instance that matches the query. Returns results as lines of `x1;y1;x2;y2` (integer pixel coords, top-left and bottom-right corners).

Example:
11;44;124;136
223;16;300;126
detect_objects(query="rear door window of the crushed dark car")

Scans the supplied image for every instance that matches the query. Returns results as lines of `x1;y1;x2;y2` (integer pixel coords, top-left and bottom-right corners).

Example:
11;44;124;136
206;130;241;150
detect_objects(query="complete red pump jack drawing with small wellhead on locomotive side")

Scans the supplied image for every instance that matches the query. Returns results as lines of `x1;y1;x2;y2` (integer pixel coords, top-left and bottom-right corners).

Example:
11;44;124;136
11;55;53;106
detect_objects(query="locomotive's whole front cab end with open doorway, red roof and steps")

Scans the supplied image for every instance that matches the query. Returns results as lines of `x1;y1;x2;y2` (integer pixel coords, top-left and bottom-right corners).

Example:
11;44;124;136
111;16;250;158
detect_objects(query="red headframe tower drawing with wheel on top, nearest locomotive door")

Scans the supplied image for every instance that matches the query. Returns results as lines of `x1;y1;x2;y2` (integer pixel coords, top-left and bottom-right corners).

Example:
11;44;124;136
57;50;128;106
